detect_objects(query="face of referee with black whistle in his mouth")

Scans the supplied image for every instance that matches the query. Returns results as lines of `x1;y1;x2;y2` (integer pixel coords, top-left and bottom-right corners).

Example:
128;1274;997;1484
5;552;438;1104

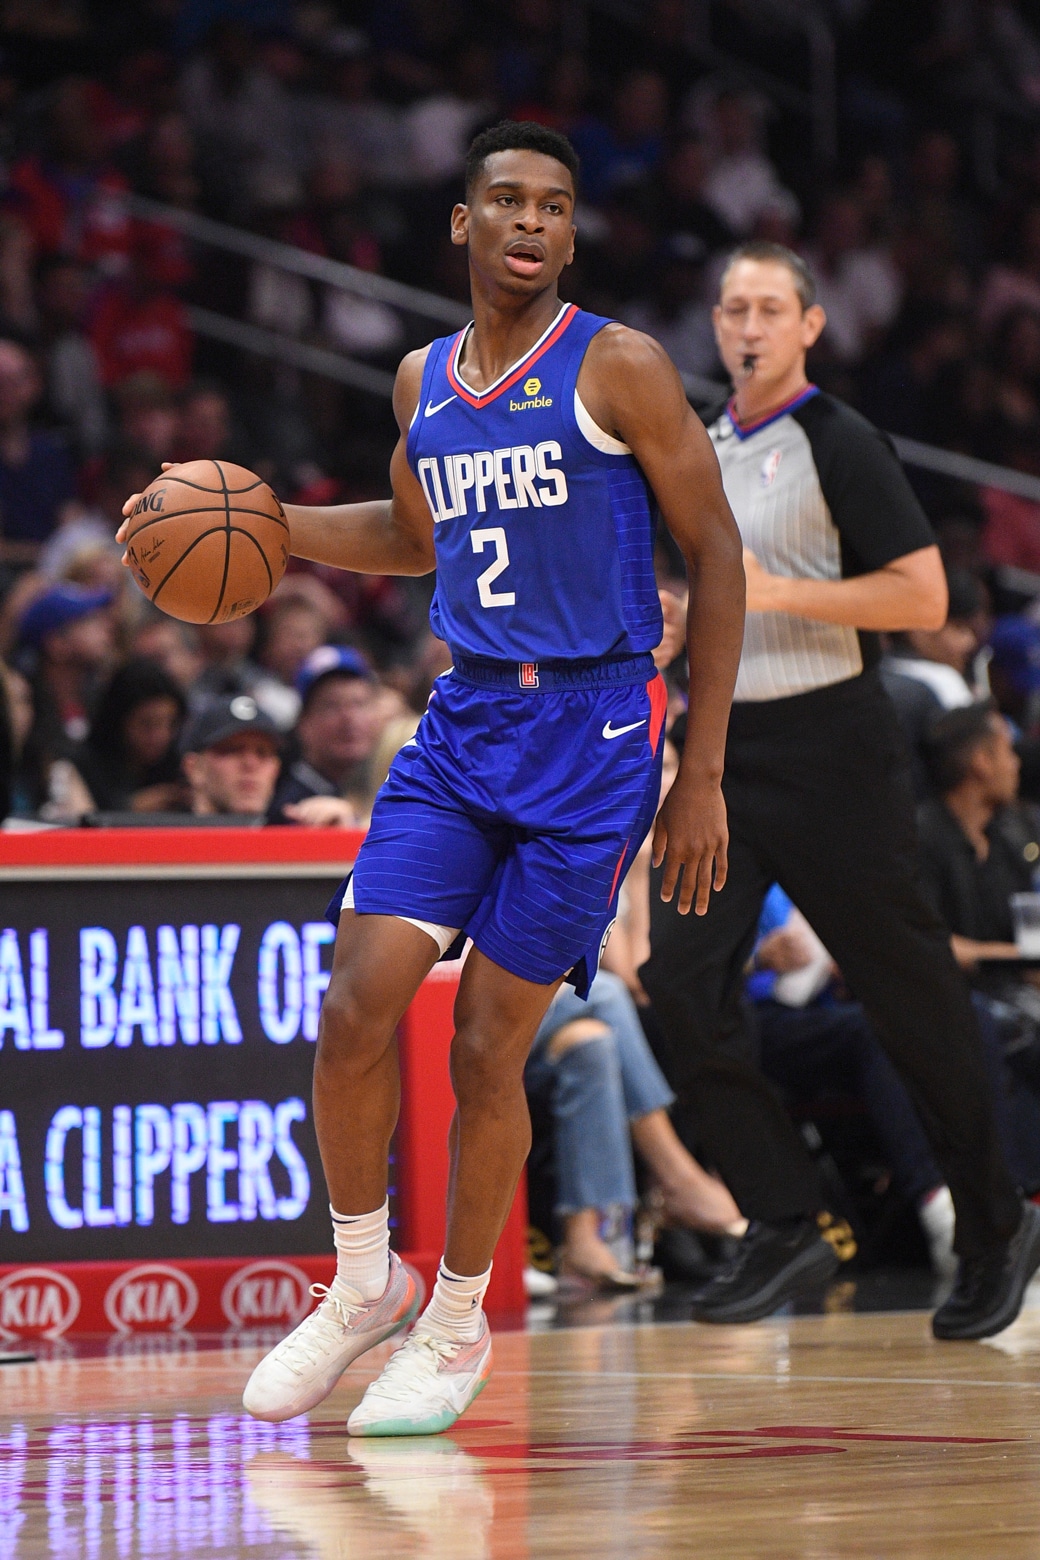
714;261;826;390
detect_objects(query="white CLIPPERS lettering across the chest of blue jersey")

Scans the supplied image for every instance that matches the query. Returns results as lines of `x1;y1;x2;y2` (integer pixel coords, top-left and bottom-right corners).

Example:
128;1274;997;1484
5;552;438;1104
416;438;568;521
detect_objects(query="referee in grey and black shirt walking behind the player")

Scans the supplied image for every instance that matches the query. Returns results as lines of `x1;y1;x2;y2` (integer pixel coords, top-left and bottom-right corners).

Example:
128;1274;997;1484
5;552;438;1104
641;243;1040;1338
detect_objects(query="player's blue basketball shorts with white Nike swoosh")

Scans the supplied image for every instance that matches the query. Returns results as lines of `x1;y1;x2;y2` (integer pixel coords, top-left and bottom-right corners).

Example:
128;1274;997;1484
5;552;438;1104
331;655;667;995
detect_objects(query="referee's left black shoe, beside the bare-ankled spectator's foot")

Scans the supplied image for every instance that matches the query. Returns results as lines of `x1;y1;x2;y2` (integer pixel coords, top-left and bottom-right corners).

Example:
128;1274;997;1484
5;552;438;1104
692;1218;840;1321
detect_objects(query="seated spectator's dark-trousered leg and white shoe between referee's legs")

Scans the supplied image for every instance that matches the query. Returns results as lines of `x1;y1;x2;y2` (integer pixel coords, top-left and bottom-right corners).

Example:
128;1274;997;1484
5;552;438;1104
748;885;956;1278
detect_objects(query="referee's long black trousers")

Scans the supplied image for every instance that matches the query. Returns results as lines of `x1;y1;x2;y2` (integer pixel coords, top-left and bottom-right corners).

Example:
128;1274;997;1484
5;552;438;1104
641;672;1021;1256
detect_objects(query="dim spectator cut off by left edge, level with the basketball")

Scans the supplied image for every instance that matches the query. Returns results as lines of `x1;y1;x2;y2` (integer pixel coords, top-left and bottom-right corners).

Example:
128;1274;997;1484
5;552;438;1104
0;342;75;558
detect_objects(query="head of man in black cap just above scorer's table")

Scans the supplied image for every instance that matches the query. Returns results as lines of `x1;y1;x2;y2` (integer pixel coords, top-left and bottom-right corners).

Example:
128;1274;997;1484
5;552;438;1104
181;694;281;824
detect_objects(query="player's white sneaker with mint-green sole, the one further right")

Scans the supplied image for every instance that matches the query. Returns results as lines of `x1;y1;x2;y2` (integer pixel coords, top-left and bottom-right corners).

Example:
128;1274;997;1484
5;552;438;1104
346;1317;491;1435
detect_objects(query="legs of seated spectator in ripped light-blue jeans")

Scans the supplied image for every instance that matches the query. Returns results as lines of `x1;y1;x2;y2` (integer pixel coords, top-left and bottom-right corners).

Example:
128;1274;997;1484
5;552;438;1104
524;970;747;1290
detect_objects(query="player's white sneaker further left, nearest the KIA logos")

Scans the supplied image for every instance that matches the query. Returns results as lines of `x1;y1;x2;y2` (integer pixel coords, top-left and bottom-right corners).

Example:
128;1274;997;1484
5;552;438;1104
242;1251;419;1423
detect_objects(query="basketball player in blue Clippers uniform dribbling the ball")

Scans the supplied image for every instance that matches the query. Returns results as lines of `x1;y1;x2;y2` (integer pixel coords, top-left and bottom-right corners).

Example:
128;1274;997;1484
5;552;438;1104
122;122;744;1435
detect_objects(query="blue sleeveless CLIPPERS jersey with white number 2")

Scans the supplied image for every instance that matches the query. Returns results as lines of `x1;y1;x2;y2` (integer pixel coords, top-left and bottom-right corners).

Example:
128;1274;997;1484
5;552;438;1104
407;304;663;661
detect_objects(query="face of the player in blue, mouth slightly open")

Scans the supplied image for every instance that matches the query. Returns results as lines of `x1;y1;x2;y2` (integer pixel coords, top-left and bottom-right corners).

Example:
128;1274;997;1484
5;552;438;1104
452;151;574;296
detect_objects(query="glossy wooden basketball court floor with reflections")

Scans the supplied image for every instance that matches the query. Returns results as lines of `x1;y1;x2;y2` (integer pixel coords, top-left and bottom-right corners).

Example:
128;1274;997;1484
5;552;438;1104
0;1293;1040;1560
